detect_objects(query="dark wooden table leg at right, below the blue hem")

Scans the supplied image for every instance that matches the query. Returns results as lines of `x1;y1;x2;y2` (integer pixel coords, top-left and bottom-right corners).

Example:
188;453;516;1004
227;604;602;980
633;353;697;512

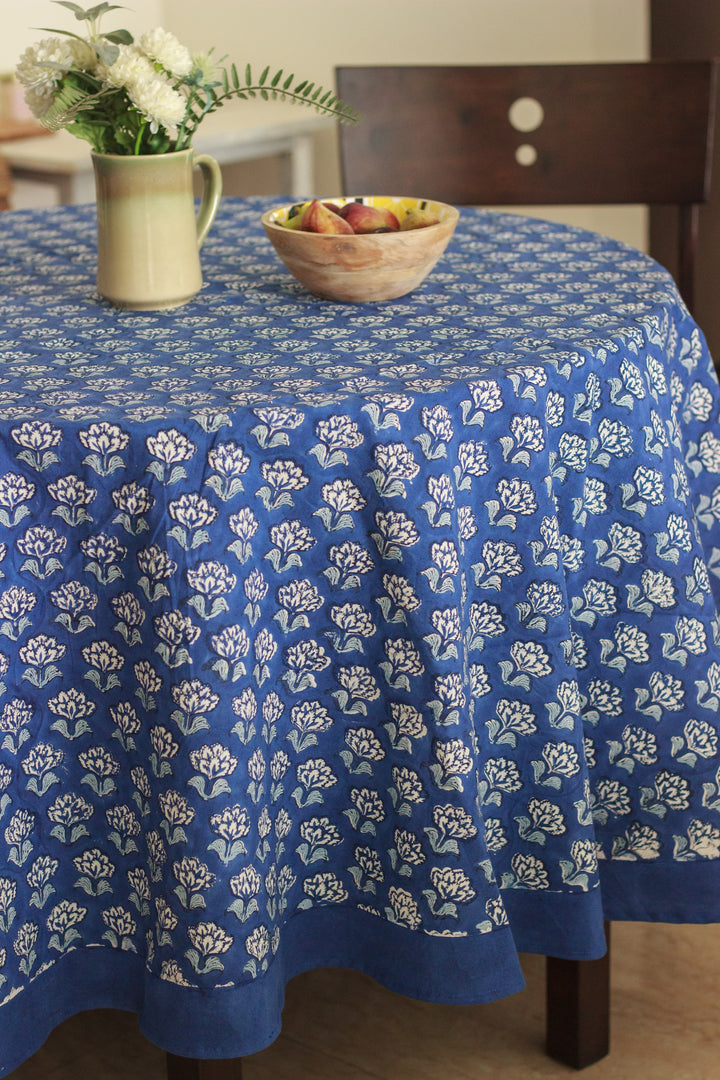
545;922;610;1069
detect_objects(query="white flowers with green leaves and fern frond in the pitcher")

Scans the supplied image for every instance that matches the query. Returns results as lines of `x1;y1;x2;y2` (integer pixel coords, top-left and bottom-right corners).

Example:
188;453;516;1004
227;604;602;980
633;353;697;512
16;0;357;156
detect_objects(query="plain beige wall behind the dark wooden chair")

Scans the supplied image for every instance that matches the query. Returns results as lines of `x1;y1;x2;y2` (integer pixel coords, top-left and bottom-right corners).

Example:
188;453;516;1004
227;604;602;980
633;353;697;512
164;0;649;246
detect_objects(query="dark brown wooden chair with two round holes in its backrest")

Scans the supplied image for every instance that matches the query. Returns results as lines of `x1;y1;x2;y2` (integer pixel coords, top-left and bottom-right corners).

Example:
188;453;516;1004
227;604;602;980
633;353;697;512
336;60;717;310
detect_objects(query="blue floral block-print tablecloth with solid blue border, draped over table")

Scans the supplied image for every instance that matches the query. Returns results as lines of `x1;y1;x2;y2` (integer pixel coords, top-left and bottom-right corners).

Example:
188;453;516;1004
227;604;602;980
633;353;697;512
0;200;720;1075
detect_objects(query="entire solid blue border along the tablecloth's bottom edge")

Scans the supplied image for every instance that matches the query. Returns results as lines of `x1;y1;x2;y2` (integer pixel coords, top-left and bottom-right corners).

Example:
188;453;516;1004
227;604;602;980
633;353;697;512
0;861;720;1077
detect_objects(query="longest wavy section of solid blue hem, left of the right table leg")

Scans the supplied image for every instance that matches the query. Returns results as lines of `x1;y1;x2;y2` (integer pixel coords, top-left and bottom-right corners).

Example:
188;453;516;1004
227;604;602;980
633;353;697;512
0;908;525;1076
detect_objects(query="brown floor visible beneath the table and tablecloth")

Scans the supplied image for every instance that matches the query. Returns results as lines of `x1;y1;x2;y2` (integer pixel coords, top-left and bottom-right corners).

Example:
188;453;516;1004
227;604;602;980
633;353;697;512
7;923;720;1080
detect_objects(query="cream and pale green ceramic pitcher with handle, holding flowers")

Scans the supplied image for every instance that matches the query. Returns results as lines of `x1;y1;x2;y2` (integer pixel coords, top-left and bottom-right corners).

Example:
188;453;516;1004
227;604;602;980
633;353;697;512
93;149;222;310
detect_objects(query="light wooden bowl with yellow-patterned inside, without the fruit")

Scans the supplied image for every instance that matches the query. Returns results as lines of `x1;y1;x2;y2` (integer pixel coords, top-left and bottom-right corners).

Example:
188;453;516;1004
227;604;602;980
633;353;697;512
262;195;459;303
